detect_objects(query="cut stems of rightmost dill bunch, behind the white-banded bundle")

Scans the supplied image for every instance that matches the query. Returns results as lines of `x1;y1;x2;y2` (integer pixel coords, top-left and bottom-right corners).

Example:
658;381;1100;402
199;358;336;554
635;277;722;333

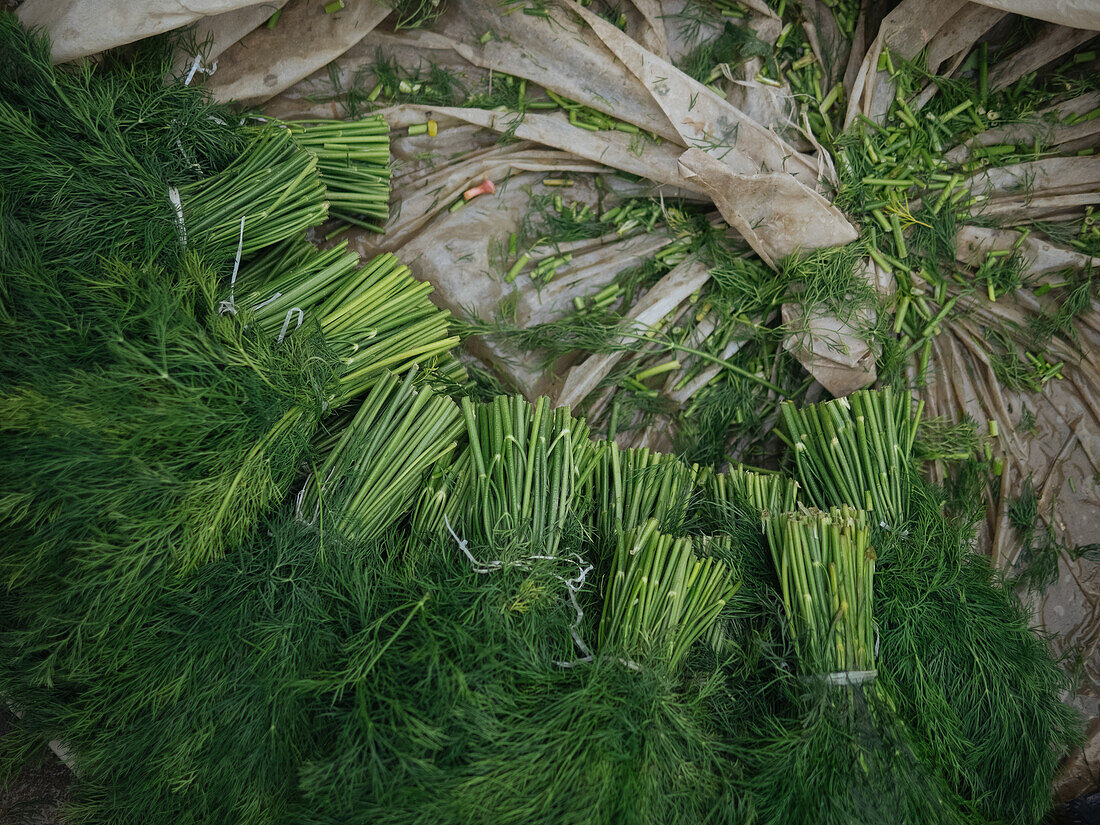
781;387;924;527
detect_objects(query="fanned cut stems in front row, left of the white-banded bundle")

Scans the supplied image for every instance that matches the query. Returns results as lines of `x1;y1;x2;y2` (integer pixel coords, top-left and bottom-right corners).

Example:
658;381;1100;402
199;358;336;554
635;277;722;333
600;518;737;671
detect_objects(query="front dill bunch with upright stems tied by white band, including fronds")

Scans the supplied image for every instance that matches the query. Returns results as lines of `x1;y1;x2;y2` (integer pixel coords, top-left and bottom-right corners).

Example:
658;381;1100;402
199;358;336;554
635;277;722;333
739;506;974;825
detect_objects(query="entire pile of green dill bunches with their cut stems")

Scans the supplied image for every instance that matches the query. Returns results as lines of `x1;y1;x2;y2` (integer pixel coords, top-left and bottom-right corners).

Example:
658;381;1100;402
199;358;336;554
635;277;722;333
0;15;1078;825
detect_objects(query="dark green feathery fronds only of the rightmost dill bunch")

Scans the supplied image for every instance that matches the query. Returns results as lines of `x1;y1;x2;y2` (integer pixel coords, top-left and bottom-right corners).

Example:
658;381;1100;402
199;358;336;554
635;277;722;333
876;480;1081;823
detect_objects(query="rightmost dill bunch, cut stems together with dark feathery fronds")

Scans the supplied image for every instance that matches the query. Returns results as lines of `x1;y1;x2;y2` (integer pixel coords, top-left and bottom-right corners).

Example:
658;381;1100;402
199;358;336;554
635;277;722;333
765;389;1077;822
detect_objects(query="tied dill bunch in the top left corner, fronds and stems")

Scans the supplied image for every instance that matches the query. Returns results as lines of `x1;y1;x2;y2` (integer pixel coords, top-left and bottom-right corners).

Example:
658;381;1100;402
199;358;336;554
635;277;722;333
0;15;328;272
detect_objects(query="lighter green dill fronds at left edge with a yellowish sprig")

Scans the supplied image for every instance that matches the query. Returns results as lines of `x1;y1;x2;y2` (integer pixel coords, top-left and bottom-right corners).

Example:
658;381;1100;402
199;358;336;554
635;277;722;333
0;257;337;684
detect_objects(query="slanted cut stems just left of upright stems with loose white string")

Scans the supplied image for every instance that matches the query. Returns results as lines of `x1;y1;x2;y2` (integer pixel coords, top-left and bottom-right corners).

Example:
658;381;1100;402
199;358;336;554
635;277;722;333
298;367;462;541
